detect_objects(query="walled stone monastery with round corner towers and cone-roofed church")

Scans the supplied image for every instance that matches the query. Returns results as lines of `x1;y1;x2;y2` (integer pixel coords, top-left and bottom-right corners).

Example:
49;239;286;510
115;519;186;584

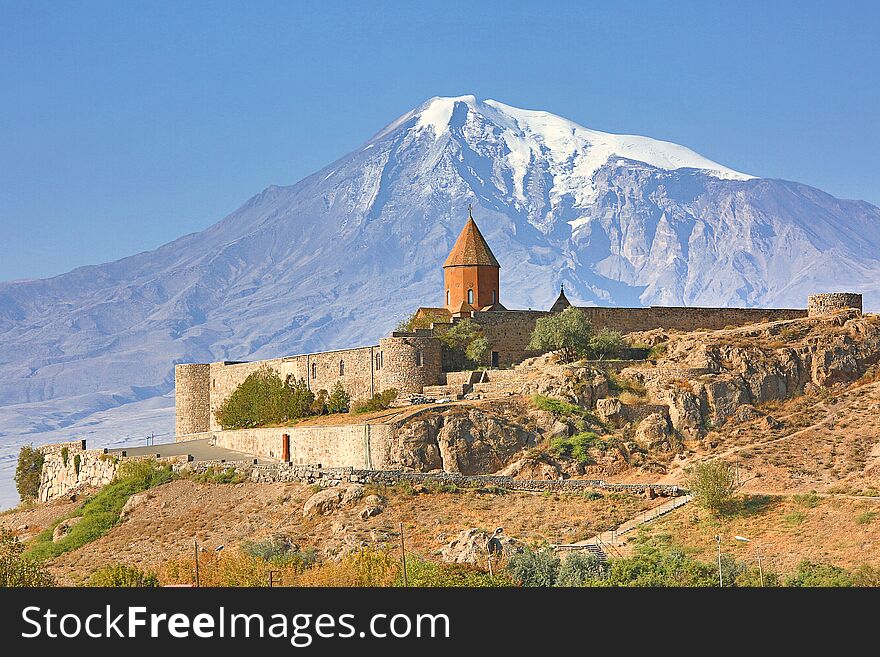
175;212;862;439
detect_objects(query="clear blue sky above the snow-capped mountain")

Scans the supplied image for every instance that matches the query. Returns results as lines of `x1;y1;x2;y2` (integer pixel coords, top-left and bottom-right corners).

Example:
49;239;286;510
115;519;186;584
0;0;880;280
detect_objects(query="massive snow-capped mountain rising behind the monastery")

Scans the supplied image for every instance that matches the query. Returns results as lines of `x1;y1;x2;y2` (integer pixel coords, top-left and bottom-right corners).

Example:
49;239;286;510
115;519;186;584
0;96;880;503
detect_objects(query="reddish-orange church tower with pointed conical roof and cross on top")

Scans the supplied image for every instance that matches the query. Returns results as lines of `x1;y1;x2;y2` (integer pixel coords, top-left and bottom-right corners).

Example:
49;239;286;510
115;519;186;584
443;207;504;315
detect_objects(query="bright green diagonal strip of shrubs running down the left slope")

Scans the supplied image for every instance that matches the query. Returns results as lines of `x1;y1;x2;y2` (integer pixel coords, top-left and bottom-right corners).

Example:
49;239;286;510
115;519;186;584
27;459;174;560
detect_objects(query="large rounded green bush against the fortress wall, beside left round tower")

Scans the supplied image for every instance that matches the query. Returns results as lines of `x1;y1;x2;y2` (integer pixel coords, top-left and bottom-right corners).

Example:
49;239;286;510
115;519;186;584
215;367;315;429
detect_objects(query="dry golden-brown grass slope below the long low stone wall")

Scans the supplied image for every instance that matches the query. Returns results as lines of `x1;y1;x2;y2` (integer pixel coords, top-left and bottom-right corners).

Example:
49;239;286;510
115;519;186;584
25;480;659;584
